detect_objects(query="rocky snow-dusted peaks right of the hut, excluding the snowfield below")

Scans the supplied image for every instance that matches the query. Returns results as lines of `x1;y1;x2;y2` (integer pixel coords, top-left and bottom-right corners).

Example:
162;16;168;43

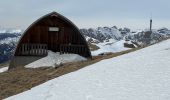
80;26;170;46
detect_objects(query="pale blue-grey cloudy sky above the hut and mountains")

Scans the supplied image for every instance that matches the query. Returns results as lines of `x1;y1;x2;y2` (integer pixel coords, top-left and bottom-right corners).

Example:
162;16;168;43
0;0;170;29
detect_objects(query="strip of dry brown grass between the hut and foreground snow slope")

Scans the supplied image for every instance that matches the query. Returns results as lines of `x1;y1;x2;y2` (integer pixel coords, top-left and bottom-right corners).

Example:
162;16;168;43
0;48;139;99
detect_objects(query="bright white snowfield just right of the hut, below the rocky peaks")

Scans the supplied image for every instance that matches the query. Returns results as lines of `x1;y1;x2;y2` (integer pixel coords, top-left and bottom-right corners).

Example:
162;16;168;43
91;39;130;56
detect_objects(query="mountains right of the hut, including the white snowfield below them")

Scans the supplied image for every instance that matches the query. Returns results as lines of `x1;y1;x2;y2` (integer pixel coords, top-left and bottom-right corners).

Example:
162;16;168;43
80;26;170;55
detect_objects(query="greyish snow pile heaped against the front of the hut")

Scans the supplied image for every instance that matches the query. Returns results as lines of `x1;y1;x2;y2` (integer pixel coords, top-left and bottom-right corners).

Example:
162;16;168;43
25;51;86;68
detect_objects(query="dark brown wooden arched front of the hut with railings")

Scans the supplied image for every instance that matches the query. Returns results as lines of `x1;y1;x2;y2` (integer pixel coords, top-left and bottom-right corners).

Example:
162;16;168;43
14;12;91;58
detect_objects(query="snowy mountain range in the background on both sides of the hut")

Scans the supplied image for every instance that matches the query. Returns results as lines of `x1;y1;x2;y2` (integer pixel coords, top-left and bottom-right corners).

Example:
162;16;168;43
0;26;170;63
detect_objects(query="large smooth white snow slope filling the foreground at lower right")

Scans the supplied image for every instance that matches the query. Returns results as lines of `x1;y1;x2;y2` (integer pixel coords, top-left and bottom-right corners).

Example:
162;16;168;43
6;40;170;100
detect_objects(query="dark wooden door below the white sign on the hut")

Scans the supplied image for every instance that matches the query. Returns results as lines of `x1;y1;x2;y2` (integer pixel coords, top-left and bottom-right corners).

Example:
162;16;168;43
48;29;60;52
